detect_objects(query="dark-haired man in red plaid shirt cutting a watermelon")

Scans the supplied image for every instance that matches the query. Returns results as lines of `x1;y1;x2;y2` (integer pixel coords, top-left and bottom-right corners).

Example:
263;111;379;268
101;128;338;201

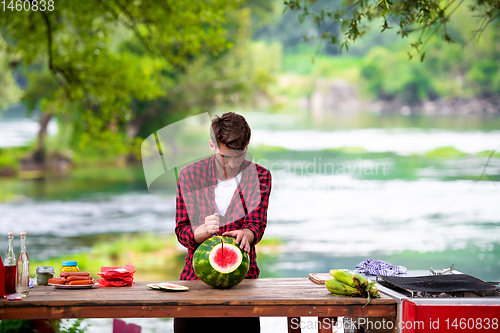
174;112;271;333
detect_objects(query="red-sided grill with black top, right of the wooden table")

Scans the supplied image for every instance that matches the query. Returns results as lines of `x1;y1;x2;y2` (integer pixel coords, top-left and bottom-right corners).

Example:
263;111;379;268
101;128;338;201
377;271;500;333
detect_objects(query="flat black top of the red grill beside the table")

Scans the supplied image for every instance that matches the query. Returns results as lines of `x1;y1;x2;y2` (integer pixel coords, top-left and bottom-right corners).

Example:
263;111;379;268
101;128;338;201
377;274;497;296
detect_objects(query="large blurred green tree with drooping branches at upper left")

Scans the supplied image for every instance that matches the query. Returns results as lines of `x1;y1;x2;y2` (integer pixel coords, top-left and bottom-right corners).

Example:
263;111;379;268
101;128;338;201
0;0;238;161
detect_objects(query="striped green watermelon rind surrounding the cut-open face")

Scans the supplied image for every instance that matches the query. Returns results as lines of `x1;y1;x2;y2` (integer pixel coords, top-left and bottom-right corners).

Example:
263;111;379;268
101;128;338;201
193;236;250;289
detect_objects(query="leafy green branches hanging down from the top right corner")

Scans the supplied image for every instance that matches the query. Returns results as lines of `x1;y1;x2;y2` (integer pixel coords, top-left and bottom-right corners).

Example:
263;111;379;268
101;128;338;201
284;0;500;61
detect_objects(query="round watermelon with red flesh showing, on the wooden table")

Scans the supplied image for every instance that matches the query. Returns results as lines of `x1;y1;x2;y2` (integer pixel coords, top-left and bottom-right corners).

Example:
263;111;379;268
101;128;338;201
193;236;250;289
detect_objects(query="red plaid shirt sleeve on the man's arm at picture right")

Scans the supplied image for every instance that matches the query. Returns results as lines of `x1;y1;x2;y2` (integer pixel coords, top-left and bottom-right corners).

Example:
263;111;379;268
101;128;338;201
242;169;271;246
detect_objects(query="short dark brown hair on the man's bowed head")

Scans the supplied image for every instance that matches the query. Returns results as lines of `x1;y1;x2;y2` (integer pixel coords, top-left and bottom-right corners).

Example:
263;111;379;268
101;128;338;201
210;112;252;150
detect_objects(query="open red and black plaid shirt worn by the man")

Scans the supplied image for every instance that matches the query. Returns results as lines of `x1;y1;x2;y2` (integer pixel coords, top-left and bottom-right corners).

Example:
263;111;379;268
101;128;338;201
175;156;271;280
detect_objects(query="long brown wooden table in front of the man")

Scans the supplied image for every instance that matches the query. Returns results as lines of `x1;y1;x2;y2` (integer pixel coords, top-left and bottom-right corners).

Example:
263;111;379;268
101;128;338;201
0;278;396;332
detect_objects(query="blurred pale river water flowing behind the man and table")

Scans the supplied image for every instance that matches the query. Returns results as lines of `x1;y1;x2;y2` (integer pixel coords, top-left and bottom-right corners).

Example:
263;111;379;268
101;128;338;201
0;112;500;332
